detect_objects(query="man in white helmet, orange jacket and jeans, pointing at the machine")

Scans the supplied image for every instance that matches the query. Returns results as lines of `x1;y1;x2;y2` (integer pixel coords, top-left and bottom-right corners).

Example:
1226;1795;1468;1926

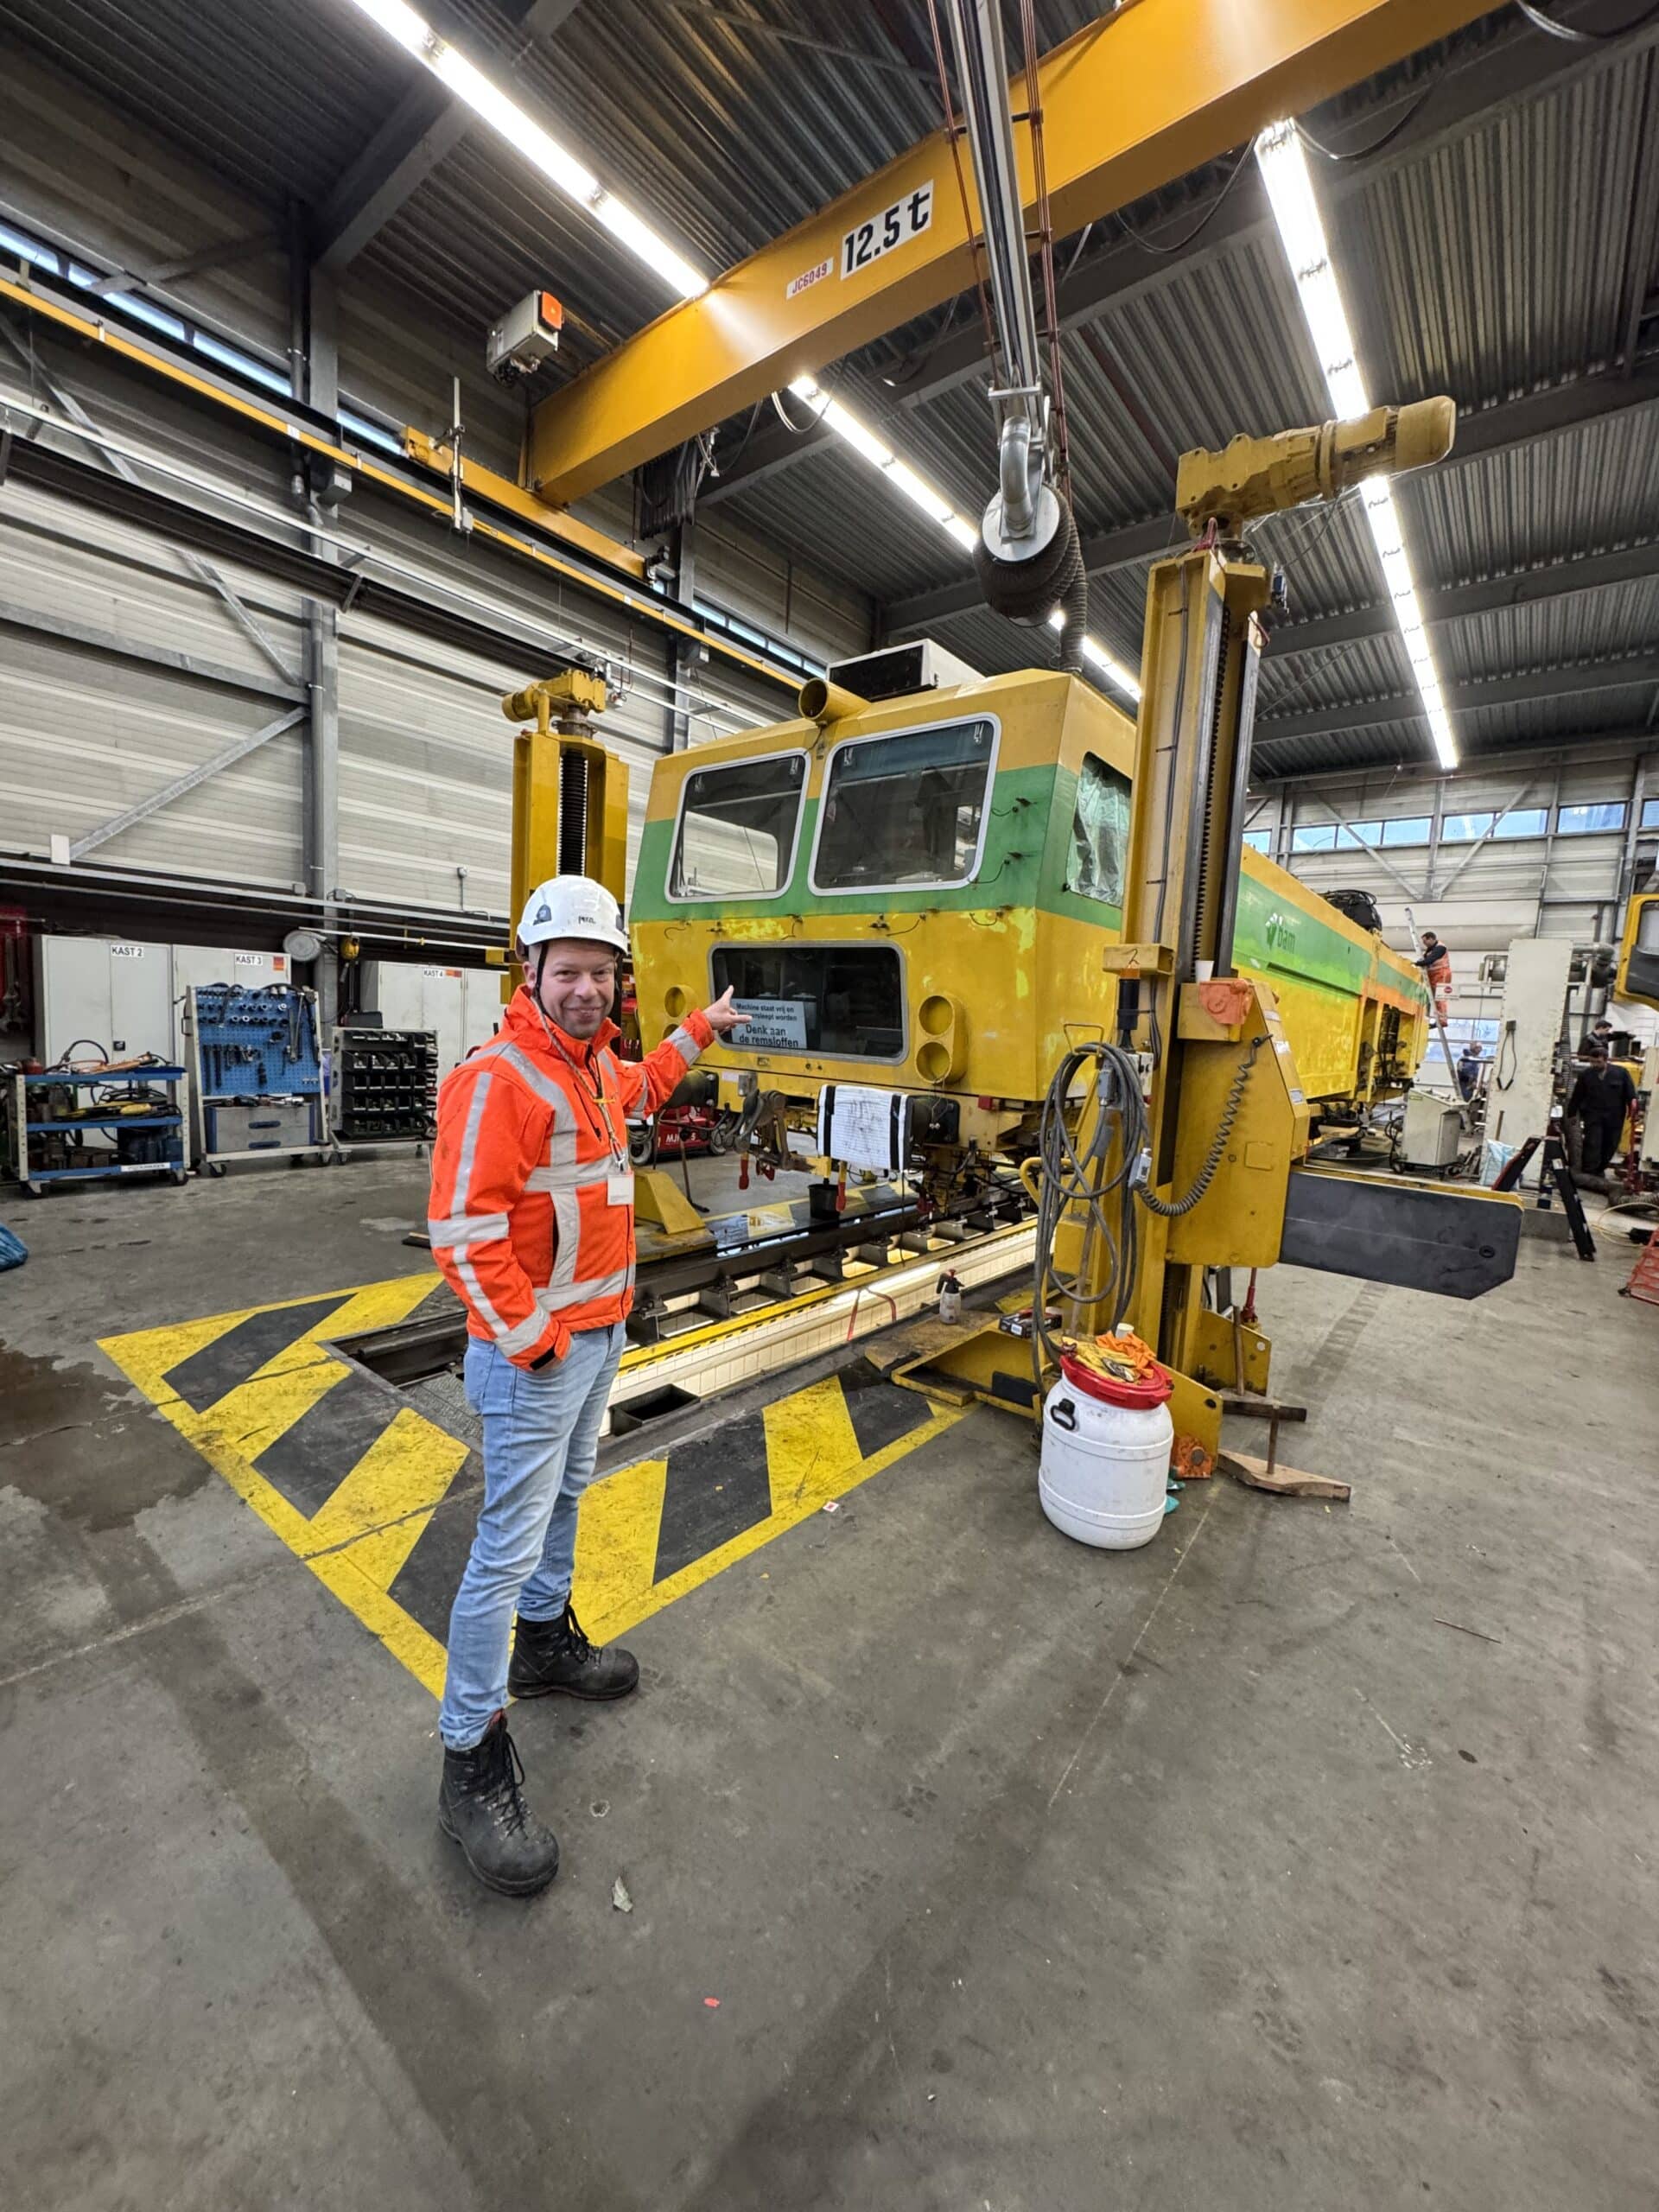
427;876;747;1896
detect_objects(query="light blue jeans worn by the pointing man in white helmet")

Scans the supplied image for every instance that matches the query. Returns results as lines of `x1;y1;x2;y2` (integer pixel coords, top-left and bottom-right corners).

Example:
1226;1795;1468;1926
438;1320;628;1752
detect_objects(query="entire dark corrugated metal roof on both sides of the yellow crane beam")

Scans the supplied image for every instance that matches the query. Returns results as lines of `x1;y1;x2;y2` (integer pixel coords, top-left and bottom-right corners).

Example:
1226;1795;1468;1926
0;0;1659;766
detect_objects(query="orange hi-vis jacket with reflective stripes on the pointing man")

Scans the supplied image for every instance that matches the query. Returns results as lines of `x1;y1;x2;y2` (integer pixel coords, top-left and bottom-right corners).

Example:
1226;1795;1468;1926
427;988;715;1367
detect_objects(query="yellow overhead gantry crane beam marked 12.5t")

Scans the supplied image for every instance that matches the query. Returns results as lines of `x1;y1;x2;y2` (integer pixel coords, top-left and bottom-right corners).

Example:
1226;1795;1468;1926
529;0;1489;505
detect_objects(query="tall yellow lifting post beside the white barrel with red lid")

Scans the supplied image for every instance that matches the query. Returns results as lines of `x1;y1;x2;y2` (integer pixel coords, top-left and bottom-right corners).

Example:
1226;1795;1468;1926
900;398;1495;1465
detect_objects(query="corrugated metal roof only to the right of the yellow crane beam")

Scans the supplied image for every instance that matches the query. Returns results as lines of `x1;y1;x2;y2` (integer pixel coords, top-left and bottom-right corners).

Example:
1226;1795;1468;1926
716;22;1659;770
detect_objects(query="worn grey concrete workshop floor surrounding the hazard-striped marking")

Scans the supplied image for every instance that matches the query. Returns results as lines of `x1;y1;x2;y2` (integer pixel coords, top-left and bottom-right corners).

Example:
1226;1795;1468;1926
0;1164;1659;2212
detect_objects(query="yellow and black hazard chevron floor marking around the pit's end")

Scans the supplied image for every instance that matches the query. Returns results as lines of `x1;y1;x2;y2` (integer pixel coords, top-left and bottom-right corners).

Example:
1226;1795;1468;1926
99;1274;963;1697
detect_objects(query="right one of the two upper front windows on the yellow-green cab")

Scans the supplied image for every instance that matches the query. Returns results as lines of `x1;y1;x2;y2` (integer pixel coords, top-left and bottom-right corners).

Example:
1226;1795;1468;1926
812;721;995;892
